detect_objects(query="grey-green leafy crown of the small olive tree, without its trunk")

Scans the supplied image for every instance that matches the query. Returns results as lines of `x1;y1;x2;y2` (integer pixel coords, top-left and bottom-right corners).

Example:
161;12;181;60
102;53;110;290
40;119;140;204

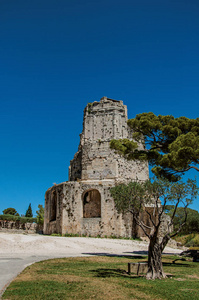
110;178;199;237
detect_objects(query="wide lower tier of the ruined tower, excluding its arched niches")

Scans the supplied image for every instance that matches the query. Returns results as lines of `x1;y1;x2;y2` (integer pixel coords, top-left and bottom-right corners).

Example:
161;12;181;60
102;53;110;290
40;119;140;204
44;181;136;237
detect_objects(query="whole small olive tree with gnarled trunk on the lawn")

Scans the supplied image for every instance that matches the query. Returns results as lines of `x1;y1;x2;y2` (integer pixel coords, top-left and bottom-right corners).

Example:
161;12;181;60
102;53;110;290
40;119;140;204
111;179;198;279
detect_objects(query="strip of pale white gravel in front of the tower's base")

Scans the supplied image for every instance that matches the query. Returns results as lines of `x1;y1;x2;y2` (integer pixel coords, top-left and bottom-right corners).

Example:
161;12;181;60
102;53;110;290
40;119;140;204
0;232;182;256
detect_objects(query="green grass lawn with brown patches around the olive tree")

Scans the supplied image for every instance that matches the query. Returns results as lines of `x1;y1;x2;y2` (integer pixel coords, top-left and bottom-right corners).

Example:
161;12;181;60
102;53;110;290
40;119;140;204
2;256;199;300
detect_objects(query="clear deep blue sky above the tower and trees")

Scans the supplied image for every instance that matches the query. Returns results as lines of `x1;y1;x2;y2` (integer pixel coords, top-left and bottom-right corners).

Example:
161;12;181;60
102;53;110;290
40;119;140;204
0;0;199;214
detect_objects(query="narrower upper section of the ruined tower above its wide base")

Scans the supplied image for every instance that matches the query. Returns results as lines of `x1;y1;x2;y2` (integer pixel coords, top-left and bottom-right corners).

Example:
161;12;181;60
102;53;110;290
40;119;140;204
69;97;148;182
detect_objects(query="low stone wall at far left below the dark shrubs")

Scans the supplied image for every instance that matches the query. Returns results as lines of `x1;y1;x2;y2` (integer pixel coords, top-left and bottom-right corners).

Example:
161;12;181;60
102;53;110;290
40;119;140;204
0;220;43;233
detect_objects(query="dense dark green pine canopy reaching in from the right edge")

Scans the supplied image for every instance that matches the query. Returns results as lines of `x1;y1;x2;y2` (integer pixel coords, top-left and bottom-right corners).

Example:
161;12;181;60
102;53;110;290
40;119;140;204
110;112;199;181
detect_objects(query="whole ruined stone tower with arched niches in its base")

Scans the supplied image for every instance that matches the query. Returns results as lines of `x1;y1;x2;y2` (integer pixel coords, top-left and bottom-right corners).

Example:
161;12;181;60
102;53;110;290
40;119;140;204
44;97;148;236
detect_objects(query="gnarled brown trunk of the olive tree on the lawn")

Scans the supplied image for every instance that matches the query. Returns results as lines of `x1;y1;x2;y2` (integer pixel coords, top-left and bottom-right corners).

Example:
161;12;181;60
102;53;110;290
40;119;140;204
146;234;166;279
